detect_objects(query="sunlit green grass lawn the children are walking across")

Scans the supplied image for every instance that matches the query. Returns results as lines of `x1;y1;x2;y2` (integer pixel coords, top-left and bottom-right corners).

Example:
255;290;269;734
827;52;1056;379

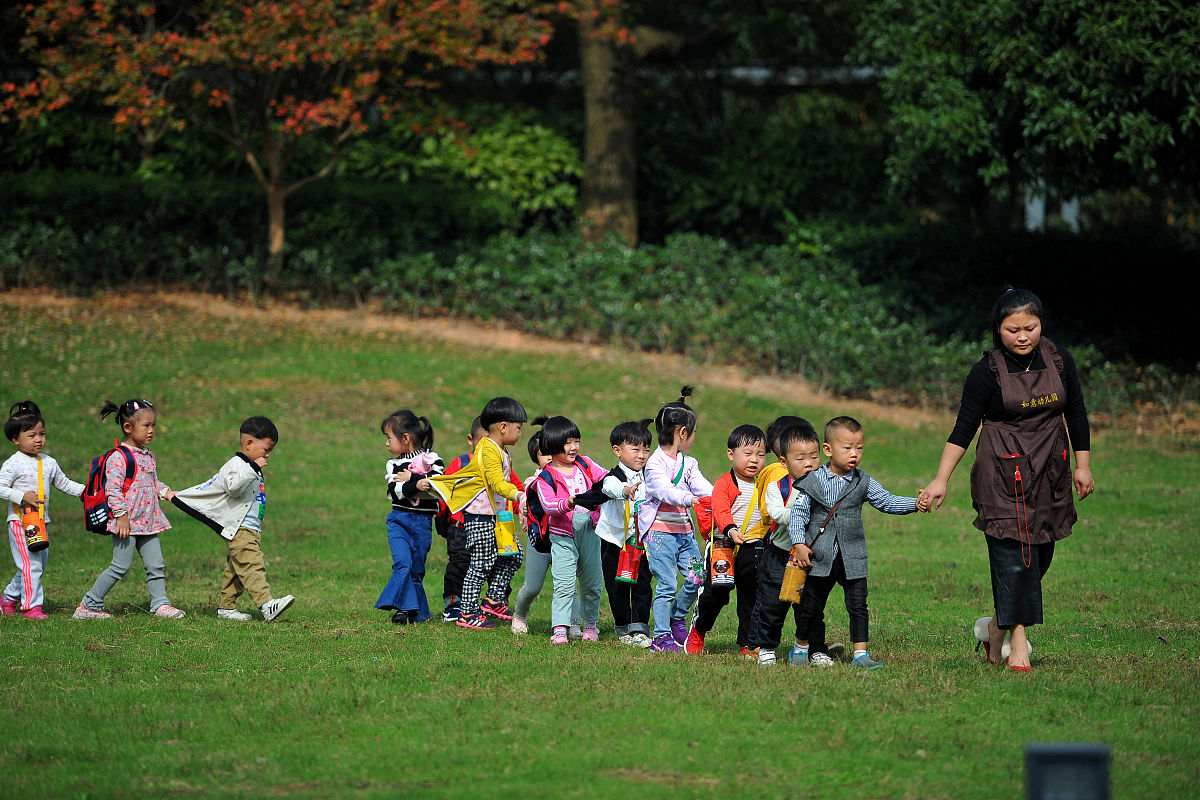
0;295;1200;798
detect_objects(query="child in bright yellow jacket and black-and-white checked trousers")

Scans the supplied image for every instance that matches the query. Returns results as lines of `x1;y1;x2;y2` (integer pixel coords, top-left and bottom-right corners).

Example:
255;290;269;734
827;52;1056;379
430;397;529;630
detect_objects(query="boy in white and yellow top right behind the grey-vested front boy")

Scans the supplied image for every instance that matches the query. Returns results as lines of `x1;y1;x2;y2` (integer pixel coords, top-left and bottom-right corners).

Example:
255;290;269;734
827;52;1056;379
751;417;840;666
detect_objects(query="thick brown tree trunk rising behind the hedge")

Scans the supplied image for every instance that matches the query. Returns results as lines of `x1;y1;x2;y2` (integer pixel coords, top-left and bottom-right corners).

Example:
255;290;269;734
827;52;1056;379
580;19;637;247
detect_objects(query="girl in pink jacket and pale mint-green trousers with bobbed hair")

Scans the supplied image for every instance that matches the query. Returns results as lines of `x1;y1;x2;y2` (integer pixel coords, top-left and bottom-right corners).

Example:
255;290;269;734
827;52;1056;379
527;416;608;644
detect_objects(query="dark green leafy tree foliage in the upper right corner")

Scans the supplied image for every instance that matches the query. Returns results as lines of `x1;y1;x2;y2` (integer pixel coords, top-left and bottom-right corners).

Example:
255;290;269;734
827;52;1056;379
862;0;1200;214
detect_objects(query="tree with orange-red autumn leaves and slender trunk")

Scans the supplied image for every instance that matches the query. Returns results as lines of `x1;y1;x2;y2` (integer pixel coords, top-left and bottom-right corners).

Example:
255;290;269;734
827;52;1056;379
0;0;551;255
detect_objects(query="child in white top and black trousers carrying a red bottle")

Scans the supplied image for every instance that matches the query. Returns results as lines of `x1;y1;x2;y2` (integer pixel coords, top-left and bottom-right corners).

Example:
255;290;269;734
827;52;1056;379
575;419;654;648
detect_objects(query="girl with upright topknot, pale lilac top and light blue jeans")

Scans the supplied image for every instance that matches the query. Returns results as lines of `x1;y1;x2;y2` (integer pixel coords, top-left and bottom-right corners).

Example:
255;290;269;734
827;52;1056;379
637;386;713;651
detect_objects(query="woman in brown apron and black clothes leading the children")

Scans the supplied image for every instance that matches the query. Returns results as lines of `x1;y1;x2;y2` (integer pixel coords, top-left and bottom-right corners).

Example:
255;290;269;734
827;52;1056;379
924;288;1096;672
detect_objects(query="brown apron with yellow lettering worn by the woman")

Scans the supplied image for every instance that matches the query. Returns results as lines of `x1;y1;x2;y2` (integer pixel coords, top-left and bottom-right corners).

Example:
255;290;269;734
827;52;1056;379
971;337;1076;545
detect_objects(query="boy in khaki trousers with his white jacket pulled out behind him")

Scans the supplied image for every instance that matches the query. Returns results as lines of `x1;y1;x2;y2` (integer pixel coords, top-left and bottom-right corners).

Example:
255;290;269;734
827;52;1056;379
167;416;295;622
